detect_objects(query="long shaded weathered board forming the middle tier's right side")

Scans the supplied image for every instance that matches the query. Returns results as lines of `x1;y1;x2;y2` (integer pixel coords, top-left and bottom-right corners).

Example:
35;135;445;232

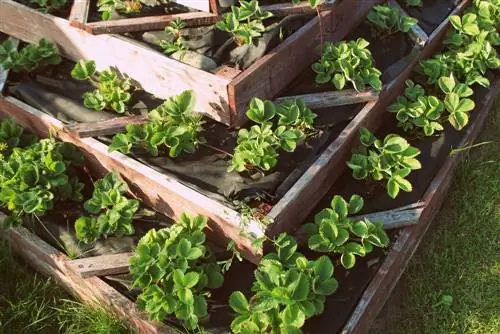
266;0;470;243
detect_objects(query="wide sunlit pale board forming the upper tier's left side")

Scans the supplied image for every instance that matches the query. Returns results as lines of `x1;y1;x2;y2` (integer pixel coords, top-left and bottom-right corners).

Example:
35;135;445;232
0;0;230;124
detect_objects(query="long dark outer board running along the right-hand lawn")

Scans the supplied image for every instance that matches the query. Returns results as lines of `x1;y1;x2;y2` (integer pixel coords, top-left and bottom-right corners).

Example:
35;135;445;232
342;79;500;334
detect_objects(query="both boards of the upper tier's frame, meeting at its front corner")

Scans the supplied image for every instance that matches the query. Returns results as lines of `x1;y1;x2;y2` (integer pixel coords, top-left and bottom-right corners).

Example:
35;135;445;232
0;0;380;126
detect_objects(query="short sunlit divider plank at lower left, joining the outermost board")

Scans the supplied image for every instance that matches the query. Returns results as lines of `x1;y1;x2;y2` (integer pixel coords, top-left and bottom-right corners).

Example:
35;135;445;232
64;253;134;278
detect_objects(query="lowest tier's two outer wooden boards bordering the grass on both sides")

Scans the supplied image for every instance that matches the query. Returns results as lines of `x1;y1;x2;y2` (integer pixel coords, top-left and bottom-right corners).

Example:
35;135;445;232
0;78;500;333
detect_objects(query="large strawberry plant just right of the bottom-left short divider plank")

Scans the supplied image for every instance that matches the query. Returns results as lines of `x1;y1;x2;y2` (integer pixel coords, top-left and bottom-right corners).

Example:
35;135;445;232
130;214;224;330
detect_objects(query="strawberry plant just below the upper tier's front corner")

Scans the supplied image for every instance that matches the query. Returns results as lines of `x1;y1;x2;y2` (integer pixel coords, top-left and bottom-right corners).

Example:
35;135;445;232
228;98;316;172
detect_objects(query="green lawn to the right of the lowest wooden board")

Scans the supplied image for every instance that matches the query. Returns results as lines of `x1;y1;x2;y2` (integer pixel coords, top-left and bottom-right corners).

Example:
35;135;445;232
373;101;500;334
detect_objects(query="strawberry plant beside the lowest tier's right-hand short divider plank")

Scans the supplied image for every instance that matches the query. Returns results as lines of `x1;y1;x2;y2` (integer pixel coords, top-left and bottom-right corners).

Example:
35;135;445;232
302;195;389;269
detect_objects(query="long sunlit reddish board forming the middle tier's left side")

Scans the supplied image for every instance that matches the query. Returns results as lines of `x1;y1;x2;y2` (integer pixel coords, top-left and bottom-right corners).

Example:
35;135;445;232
0;96;264;263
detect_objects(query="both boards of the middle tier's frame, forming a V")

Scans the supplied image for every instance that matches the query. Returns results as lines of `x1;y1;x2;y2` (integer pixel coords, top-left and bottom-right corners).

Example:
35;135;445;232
0;0;468;262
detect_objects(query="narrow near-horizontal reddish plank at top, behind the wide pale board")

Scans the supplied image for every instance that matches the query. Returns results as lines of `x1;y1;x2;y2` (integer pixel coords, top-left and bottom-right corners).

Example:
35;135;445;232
78;12;220;35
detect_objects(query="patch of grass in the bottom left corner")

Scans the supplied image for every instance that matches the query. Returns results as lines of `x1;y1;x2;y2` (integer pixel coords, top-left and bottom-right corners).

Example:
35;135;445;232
0;242;130;334
